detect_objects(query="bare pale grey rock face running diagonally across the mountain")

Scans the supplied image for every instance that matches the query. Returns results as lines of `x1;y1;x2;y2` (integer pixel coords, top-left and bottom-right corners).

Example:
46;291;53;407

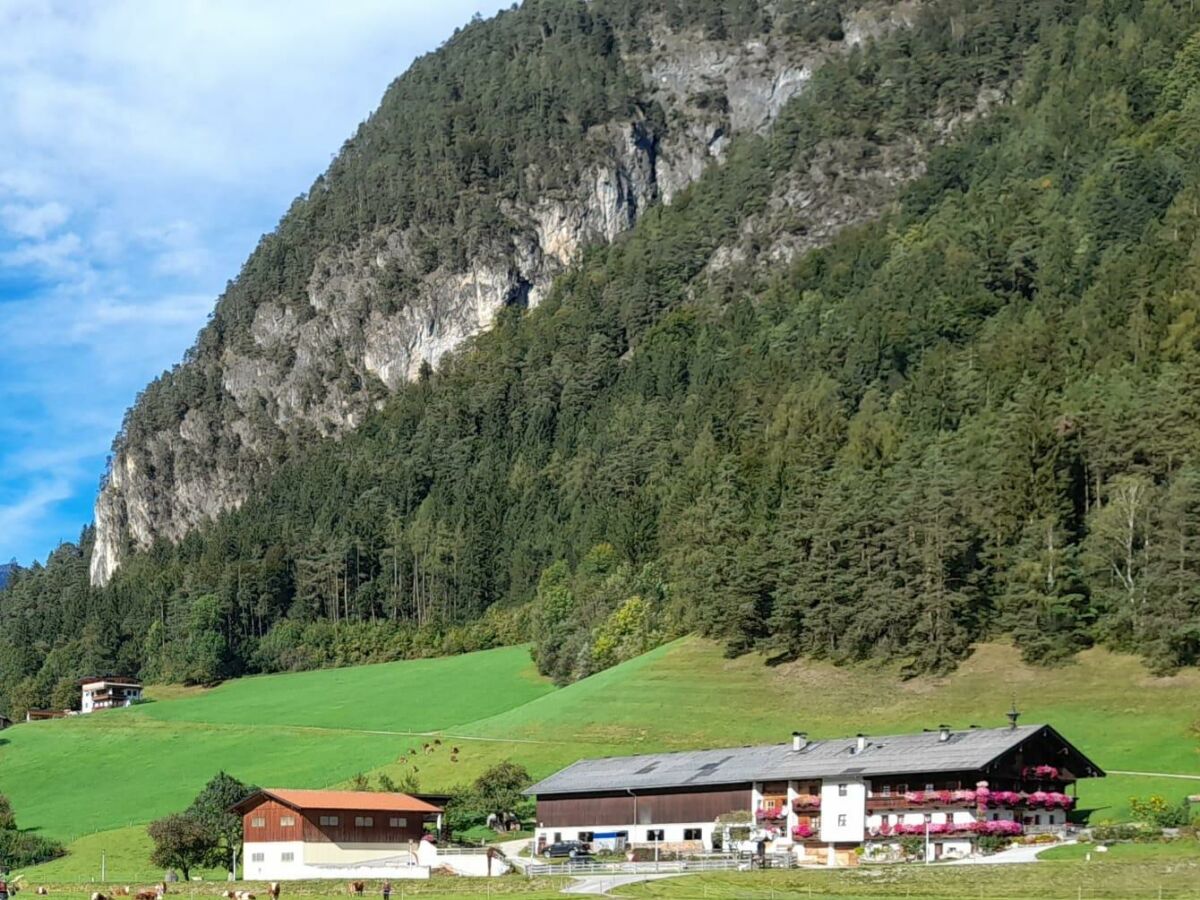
91;4;912;584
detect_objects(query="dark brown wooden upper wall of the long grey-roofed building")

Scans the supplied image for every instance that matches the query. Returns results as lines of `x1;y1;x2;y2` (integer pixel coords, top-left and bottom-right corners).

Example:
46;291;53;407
538;785;750;828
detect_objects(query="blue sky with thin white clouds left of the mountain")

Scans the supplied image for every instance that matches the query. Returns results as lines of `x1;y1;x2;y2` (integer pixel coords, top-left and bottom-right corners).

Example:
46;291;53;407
0;0;510;563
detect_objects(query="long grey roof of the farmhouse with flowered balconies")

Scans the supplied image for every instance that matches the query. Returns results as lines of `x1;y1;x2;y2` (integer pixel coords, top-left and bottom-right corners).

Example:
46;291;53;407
526;725;1103;794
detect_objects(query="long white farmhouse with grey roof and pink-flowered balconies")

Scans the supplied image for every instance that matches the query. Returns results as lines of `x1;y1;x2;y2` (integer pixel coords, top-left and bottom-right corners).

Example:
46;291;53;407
527;712;1104;865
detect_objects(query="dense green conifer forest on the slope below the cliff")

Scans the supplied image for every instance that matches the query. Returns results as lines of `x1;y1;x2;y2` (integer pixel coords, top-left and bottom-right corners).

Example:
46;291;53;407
0;0;1200;714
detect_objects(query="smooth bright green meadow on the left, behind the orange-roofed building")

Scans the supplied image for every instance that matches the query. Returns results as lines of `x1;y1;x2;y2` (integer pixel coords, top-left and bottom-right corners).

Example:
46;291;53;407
0;647;552;839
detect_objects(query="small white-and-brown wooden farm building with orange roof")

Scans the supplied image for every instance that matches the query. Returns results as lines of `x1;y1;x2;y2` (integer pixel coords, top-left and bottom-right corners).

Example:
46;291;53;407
233;788;442;881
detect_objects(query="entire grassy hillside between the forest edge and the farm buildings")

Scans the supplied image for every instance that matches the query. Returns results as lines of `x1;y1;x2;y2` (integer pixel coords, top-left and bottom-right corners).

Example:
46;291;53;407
9;638;1200;877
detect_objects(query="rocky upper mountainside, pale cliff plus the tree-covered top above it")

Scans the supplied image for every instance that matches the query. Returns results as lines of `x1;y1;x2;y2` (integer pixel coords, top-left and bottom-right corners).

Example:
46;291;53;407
91;0;916;584
